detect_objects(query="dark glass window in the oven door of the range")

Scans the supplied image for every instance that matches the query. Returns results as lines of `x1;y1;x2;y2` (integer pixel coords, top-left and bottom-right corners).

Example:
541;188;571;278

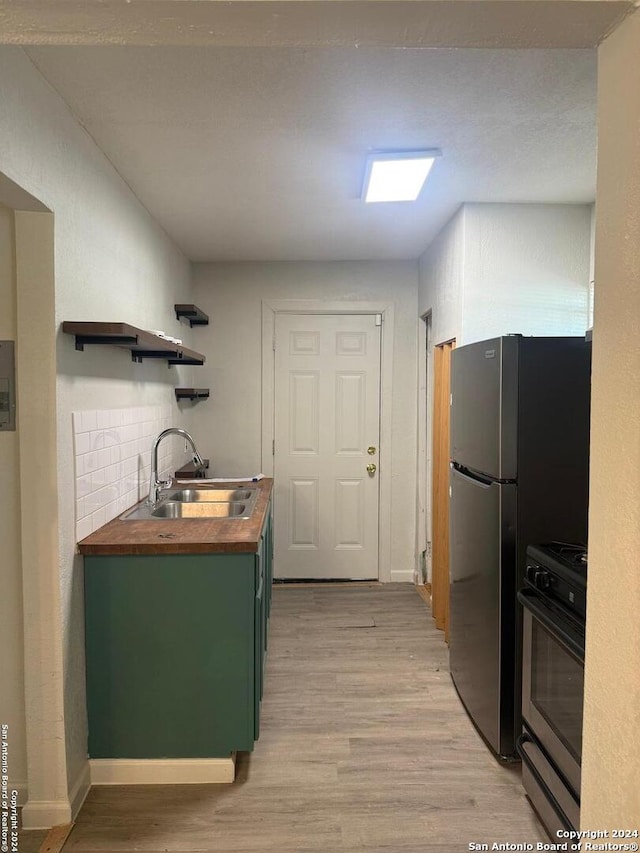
531;619;584;763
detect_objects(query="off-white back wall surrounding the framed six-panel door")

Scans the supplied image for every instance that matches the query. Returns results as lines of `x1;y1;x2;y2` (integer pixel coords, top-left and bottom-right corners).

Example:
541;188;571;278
194;262;418;578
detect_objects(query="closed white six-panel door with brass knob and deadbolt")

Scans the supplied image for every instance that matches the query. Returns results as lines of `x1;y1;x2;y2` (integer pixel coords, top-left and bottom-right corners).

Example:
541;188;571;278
274;314;381;580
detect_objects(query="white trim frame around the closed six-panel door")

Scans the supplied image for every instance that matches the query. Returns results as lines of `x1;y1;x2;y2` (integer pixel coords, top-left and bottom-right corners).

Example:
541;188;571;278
261;299;394;583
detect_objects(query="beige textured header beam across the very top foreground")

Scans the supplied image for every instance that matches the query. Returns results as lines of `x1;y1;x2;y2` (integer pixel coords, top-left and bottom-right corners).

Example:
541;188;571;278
0;0;636;48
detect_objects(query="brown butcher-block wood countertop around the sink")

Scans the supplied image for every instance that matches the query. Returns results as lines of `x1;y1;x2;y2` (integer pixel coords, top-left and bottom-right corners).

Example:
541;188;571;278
78;478;273;555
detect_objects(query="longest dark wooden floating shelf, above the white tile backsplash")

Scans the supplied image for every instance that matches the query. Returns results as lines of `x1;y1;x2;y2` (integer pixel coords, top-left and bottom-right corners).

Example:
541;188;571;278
62;321;206;364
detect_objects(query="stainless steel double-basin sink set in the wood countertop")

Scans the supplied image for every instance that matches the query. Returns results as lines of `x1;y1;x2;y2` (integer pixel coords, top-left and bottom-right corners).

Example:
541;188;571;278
121;486;259;521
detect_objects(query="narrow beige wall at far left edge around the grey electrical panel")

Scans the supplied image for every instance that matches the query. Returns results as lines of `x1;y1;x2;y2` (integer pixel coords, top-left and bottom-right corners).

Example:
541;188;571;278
0;205;27;800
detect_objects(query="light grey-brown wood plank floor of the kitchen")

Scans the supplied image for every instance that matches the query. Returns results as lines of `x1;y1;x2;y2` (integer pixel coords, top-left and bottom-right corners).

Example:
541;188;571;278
57;584;548;853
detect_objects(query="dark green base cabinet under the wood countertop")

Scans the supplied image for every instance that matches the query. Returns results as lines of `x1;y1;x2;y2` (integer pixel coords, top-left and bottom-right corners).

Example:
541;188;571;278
85;502;272;758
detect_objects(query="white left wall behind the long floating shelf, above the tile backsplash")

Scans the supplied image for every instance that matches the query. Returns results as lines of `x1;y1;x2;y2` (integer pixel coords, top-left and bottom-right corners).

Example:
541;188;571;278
0;47;197;820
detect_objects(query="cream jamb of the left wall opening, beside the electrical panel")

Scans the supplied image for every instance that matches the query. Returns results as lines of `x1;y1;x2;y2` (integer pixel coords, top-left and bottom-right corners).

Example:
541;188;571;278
0;172;70;829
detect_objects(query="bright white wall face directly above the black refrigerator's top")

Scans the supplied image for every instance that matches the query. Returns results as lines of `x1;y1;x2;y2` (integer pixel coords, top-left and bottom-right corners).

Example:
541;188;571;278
459;204;591;345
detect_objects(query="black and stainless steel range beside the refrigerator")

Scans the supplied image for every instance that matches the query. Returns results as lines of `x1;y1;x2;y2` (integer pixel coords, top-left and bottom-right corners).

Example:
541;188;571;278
518;542;587;838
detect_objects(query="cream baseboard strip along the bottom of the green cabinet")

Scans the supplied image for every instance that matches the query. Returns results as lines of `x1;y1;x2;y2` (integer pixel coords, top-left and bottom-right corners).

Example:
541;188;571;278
89;752;236;785
